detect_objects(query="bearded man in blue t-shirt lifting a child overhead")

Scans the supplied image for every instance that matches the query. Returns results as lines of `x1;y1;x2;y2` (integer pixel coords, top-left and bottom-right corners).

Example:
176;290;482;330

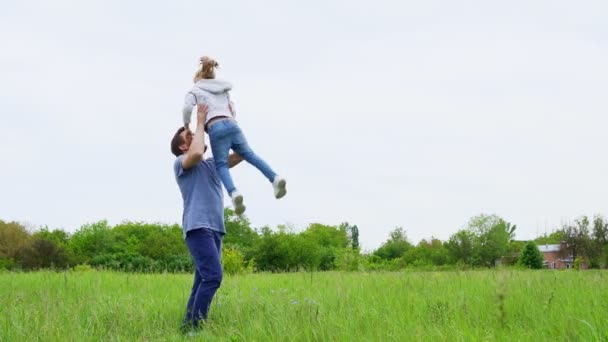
171;105;242;330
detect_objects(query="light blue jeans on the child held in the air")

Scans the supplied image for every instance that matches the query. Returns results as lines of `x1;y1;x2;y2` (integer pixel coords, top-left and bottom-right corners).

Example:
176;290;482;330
209;119;276;195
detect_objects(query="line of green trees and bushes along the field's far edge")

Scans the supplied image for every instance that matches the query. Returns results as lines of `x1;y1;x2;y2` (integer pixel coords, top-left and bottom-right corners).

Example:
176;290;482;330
0;209;608;273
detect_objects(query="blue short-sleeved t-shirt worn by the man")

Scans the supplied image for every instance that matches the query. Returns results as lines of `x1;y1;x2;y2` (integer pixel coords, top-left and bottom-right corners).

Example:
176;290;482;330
173;155;226;237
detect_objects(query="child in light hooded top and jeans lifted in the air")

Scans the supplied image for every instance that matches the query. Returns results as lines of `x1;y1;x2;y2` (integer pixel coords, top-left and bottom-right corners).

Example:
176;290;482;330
183;56;287;215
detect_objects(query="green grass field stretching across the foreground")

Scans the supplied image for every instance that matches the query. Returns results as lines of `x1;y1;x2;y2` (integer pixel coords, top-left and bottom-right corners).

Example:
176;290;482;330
0;270;608;341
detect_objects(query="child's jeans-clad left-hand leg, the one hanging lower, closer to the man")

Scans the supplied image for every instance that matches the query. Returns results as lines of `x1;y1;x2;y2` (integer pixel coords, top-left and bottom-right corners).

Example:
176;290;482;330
209;121;236;195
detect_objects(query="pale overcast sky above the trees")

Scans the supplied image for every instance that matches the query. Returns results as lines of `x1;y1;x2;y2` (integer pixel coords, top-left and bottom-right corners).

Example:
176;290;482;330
0;0;608;250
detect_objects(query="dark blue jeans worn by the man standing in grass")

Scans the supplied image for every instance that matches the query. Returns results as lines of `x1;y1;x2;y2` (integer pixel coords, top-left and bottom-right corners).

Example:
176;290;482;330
183;228;222;328
